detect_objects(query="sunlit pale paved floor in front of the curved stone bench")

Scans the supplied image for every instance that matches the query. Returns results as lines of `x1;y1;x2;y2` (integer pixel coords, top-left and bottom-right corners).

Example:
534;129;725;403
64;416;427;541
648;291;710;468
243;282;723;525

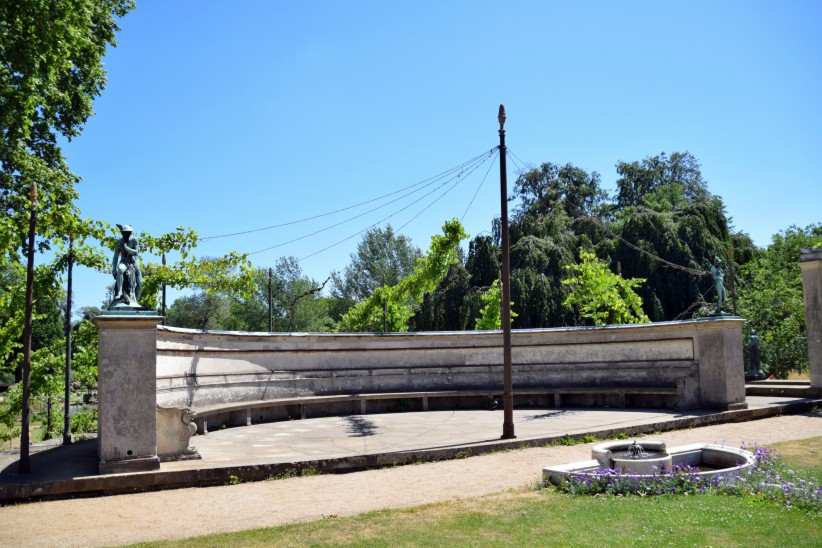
171;397;787;470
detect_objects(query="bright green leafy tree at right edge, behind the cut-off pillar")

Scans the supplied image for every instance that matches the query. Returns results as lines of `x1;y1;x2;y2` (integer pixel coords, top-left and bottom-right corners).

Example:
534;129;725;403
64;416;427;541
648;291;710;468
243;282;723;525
738;224;822;378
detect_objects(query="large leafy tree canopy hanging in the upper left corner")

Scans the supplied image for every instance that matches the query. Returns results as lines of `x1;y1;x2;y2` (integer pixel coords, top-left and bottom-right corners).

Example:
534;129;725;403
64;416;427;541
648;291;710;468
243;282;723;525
0;0;133;266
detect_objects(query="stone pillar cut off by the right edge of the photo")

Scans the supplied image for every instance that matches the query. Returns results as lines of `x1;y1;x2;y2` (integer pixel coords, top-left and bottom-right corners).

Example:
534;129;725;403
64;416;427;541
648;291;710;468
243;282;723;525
799;249;822;394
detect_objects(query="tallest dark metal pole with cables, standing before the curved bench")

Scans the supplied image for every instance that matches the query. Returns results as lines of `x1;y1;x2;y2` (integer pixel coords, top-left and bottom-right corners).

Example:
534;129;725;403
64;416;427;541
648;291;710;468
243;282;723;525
497;105;516;440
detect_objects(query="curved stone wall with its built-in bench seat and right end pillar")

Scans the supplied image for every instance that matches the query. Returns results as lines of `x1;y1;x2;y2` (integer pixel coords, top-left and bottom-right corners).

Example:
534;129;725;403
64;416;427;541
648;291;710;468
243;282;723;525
157;317;745;440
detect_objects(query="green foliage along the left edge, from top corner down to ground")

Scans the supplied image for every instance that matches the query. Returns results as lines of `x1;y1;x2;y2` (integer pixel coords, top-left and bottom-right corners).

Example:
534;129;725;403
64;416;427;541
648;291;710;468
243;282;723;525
0;0;133;440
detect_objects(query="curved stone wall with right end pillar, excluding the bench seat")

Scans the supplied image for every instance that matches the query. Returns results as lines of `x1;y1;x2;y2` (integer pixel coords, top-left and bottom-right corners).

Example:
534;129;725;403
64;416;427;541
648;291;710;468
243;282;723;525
157;318;745;408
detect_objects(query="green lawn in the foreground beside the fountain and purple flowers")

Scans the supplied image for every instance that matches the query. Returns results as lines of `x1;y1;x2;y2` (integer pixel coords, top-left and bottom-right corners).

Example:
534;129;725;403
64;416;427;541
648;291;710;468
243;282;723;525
132;437;822;547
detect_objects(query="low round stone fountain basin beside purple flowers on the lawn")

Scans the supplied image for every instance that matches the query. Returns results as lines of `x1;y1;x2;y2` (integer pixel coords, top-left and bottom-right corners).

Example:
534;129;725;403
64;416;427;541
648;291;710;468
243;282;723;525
542;440;756;485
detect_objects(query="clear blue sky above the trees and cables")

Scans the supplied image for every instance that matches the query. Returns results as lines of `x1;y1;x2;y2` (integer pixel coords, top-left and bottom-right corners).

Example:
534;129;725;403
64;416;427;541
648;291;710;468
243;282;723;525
65;0;822;312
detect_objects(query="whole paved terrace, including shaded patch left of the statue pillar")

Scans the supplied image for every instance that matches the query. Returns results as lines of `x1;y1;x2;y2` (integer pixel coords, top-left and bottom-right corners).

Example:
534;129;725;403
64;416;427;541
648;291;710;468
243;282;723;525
0;396;812;487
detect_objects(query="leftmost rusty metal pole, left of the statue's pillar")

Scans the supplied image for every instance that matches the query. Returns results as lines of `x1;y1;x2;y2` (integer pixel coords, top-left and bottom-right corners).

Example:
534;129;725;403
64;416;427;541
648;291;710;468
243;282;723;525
18;182;37;474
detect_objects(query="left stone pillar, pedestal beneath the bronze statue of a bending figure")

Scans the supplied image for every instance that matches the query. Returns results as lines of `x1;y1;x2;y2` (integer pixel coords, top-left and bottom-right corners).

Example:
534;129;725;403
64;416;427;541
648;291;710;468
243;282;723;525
94;311;162;474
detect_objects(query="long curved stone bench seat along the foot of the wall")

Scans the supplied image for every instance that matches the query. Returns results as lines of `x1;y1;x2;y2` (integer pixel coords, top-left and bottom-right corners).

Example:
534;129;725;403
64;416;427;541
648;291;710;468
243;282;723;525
191;385;679;434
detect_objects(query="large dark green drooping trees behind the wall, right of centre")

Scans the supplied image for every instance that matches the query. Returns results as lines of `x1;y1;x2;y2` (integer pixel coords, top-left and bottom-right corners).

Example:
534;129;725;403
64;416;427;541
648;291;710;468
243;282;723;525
412;152;756;338
